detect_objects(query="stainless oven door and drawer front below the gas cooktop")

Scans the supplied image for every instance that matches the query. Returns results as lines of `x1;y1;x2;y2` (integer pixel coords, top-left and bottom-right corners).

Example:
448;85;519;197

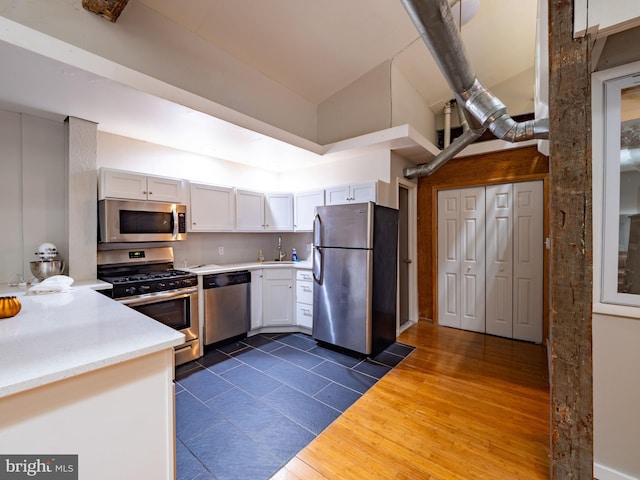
118;287;200;365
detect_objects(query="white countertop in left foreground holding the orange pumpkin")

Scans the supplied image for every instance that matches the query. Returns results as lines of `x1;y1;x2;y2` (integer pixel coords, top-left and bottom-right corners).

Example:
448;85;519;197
0;285;184;398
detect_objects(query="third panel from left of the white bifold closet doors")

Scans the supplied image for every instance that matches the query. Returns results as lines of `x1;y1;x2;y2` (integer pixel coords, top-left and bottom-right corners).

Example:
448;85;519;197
486;184;513;337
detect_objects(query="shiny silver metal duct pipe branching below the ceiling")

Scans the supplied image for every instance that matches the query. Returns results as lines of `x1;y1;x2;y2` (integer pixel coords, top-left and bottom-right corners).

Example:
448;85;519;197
401;0;549;178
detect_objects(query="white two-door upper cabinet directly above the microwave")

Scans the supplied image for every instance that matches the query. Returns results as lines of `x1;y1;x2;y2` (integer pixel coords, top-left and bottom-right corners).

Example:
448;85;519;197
98;169;184;203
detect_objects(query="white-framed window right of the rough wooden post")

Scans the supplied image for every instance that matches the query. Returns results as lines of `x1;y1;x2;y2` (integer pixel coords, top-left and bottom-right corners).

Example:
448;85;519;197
594;73;640;306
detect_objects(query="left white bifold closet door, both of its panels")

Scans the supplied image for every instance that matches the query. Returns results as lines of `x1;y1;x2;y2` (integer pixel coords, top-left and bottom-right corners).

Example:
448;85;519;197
438;187;485;332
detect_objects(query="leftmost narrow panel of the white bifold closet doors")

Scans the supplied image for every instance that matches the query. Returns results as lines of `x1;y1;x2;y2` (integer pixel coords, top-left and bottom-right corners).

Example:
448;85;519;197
438;190;461;328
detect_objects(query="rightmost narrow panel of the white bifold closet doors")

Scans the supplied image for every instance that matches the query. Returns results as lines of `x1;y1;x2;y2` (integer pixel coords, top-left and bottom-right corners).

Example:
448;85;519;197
513;181;544;343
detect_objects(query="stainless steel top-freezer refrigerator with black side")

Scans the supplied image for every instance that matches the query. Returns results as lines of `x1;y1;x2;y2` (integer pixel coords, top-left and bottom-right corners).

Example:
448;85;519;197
313;202;398;356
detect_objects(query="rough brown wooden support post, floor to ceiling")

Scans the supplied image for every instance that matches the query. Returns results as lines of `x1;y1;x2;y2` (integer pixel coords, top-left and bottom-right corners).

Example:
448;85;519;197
549;0;593;479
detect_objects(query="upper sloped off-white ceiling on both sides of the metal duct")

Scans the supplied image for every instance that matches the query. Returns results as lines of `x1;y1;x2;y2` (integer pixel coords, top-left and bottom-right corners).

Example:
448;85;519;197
139;0;537;112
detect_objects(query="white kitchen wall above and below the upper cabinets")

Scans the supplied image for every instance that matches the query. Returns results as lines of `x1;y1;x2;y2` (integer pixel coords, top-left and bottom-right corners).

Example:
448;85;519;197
97;132;396;266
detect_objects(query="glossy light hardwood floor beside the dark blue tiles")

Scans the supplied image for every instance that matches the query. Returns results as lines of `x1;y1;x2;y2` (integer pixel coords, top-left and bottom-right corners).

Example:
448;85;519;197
273;322;549;480
